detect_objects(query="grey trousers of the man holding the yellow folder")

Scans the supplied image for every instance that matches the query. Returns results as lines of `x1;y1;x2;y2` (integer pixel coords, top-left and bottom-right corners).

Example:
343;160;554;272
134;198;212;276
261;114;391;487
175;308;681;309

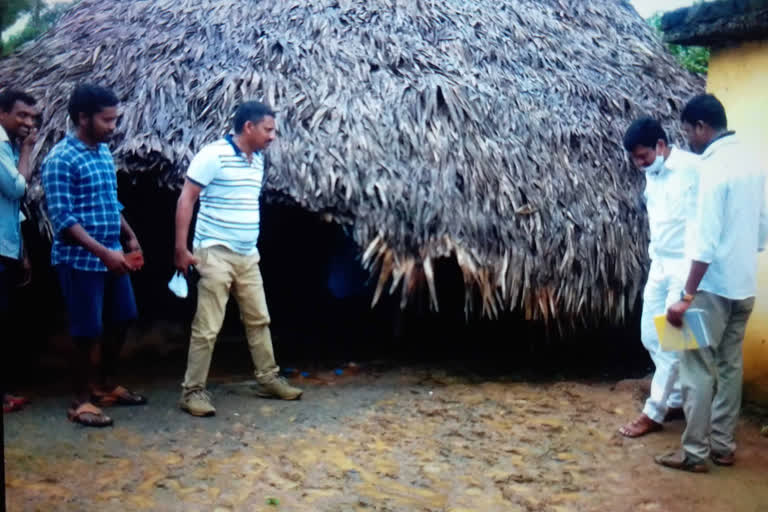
680;292;755;462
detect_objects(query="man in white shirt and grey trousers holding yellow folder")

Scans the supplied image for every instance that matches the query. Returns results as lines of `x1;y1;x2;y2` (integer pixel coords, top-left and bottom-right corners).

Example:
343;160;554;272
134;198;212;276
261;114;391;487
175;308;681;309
655;94;768;472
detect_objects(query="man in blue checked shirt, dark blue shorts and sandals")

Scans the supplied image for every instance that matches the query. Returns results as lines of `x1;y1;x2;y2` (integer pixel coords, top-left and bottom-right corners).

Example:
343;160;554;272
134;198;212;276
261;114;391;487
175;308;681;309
42;84;147;427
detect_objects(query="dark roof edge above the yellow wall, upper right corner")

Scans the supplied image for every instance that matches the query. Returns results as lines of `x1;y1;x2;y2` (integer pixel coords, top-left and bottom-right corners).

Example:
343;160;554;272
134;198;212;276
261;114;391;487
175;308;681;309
661;0;768;46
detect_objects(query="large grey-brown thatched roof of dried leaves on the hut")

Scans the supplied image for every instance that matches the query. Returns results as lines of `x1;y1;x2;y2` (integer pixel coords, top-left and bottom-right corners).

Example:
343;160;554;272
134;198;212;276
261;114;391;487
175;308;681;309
0;0;703;321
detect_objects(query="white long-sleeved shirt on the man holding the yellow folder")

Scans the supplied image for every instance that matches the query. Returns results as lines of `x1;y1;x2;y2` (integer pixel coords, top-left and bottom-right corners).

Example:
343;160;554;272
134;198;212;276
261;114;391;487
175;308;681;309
688;135;768;300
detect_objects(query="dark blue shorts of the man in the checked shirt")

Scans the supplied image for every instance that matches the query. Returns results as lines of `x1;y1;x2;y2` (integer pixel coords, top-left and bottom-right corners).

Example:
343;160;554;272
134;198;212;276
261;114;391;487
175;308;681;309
56;265;138;338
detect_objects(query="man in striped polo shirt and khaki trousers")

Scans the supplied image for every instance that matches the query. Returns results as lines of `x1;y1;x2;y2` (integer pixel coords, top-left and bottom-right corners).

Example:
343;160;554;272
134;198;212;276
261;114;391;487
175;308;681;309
175;102;302;416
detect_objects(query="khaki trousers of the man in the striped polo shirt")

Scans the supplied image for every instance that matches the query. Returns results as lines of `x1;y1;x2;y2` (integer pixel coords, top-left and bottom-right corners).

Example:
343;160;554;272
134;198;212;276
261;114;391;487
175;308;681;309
182;246;279;391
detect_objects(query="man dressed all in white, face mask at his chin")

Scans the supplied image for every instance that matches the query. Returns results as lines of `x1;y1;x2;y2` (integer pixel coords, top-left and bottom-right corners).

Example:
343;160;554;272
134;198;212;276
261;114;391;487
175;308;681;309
619;117;698;437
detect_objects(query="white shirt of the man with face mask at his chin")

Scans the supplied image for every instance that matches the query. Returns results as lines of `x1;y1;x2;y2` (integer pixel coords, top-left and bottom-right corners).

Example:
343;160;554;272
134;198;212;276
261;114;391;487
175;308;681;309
645;146;699;260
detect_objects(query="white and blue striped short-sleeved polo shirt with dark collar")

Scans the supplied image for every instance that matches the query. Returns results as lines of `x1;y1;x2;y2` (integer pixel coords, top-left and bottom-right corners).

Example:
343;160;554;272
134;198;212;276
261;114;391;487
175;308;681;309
187;135;264;255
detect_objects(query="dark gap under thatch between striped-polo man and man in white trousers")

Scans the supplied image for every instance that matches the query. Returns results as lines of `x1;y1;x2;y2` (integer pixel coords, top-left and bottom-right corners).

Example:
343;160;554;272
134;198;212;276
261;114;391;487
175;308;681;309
260;201;650;379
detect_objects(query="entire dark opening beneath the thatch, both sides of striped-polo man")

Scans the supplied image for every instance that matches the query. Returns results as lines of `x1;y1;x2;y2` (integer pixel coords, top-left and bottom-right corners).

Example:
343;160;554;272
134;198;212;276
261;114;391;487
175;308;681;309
13;172;649;377
